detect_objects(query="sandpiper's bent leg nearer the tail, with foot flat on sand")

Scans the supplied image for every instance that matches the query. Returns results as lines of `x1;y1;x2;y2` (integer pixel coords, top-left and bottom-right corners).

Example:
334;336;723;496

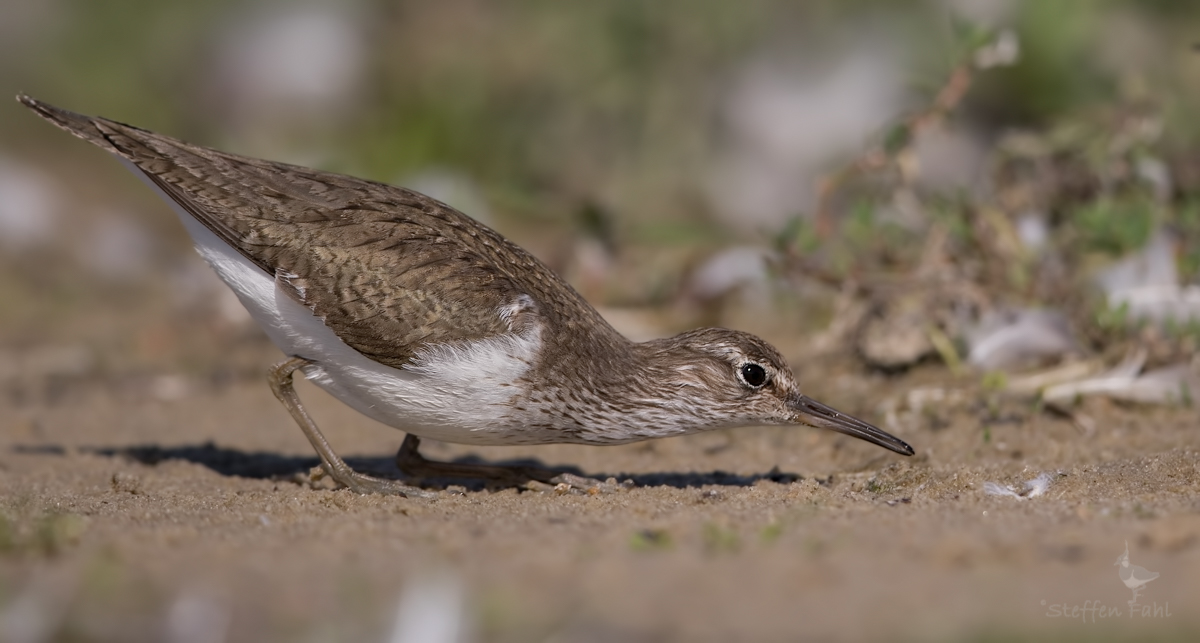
266;357;437;498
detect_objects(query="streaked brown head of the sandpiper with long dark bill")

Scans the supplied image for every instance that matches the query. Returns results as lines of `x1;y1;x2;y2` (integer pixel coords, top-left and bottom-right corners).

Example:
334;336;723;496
642;329;913;456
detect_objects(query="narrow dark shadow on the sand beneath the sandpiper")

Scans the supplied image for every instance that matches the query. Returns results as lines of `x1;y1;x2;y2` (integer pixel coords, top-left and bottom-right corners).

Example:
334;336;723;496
13;441;802;491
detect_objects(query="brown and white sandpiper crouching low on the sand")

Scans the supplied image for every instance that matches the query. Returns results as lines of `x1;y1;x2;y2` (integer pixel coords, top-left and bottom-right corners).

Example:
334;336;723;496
17;94;914;497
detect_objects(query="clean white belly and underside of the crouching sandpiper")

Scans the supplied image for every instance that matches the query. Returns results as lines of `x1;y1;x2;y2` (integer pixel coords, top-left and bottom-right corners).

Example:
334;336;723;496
127;163;541;444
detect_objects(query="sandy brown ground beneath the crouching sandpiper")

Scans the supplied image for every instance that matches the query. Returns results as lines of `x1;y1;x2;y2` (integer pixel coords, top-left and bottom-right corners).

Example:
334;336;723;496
0;302;1200;642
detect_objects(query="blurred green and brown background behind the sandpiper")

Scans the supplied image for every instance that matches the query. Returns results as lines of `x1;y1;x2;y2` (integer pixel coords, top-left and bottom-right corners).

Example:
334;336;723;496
0;0;1200;367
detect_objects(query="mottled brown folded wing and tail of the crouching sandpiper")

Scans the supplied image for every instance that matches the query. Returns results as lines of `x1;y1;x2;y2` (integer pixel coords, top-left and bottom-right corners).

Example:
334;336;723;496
18;96;554;366
